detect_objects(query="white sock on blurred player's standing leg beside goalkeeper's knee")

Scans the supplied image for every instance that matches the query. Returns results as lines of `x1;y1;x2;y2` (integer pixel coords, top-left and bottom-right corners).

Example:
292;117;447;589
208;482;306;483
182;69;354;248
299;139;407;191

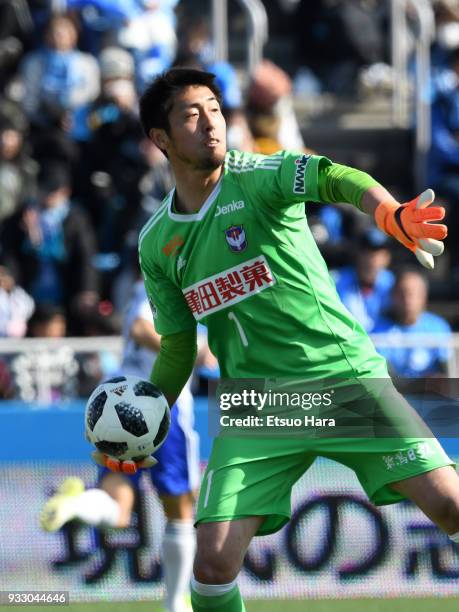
163;520;196;612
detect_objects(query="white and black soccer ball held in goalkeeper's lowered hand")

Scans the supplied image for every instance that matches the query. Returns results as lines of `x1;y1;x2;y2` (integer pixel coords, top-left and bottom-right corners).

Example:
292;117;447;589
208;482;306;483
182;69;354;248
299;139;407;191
84;376;170;461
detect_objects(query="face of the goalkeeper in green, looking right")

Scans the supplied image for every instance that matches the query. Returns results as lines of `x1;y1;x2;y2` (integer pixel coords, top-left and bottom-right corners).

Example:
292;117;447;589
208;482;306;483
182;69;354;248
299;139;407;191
152;85;226;171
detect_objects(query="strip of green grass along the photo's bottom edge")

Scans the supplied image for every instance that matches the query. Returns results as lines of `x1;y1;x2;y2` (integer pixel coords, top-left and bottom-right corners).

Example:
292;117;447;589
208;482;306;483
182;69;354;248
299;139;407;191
0;597;459;612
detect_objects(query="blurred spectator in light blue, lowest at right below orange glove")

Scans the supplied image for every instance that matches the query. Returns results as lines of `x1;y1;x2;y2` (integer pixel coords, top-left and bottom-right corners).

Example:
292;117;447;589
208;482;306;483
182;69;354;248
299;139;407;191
373;268;451;378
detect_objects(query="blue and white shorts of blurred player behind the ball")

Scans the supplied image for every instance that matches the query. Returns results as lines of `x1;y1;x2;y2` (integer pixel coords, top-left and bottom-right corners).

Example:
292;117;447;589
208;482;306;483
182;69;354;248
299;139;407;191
99;388;200;495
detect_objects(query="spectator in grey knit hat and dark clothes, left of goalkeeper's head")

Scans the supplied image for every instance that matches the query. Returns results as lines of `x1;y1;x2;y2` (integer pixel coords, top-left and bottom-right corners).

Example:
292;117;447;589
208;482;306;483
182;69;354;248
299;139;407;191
78;47;147;253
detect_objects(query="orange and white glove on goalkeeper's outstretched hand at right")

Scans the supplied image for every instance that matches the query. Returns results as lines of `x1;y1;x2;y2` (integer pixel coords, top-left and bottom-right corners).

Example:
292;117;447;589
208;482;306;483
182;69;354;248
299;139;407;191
375;189;448;270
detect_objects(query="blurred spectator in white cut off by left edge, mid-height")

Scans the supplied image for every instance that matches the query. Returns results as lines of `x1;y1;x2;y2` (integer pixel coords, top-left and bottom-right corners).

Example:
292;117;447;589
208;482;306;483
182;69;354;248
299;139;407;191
0;266;35;338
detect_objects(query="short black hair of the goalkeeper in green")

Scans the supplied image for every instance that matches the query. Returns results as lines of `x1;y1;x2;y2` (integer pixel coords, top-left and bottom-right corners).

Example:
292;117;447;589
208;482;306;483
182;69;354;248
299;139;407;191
139;68;222;136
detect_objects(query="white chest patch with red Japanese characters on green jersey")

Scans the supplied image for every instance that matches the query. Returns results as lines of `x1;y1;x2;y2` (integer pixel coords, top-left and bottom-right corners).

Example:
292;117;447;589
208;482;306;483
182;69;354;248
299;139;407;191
182;255;276;321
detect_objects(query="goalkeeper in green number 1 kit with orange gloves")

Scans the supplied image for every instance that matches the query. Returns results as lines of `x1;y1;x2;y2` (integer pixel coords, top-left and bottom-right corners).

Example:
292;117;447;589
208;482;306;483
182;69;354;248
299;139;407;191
105;69;459;612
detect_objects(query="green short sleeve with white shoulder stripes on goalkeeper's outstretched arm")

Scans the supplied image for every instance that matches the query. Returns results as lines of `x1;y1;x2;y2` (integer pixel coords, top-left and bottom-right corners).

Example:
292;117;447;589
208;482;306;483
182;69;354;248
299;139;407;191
228;151;332;207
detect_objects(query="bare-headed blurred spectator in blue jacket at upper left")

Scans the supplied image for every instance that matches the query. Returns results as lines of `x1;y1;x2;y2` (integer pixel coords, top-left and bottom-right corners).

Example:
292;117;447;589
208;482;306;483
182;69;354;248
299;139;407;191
22;14;99;126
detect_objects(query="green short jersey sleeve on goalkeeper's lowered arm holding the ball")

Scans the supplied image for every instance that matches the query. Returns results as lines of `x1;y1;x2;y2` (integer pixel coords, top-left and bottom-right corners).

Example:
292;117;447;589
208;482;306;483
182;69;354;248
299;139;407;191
139;252;196;336
